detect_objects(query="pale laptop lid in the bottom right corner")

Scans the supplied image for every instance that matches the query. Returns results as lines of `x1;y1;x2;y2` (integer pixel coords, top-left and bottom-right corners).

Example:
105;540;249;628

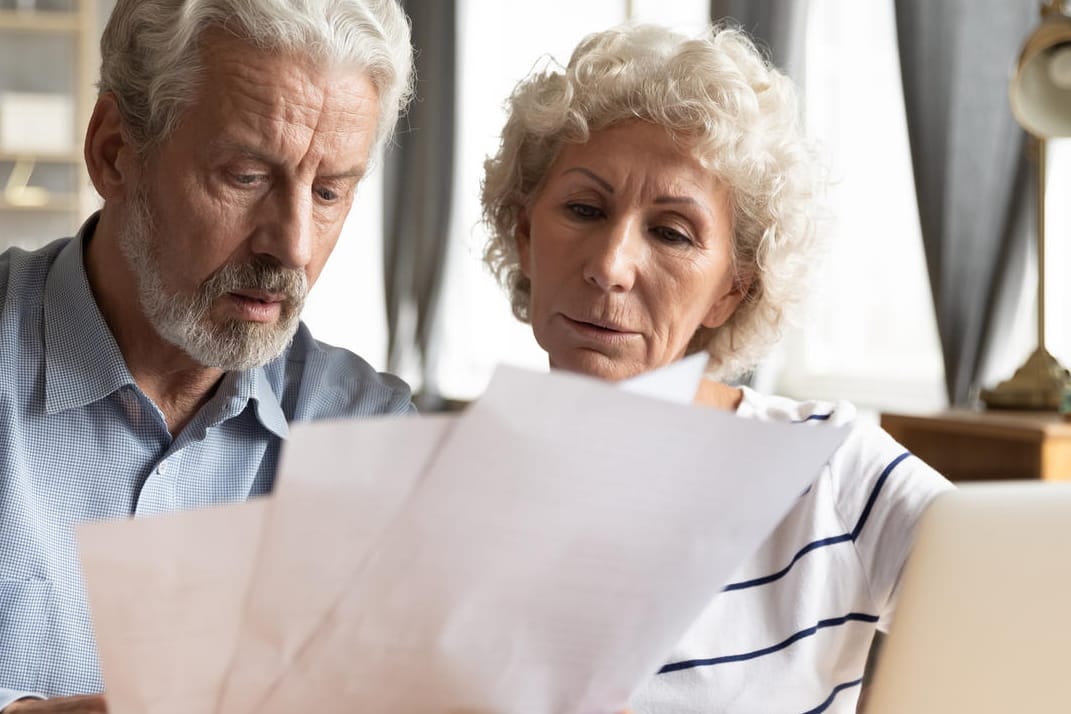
864;481;1071;714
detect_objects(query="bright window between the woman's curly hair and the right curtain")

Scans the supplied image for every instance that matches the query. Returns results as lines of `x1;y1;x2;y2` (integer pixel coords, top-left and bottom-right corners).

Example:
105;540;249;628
759;0;946;409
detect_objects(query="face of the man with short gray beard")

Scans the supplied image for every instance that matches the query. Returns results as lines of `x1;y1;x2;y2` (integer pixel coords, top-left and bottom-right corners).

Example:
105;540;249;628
121;34;379;369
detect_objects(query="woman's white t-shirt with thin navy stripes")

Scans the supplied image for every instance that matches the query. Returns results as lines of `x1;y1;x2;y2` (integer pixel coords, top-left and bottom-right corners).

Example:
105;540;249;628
632;389;950;714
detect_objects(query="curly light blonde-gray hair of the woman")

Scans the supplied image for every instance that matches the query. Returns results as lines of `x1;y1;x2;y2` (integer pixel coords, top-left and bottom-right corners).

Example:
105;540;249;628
482;25;820;379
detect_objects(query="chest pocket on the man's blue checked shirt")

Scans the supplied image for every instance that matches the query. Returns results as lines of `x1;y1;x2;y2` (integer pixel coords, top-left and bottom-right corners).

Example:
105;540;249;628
0;577;51;690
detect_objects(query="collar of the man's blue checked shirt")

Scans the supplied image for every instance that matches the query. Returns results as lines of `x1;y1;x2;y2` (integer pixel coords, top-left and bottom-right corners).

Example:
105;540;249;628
43;212;289;439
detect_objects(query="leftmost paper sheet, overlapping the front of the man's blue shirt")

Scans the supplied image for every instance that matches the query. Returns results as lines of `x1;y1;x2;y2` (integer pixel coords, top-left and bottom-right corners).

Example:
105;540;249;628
78;499;268;714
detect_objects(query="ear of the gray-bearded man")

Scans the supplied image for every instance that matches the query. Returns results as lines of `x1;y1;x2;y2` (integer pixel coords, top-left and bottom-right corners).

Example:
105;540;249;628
84;92;137;200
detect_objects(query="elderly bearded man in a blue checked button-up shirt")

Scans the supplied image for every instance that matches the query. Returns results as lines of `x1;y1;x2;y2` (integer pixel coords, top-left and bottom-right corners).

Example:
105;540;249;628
0;0;411;712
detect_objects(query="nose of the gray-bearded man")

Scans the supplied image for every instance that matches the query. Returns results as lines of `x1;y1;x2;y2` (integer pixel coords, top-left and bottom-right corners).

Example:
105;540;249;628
252;187;315;270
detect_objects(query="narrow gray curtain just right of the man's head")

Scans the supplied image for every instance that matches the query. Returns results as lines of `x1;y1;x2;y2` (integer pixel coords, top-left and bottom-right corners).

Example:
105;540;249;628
383;0;457;411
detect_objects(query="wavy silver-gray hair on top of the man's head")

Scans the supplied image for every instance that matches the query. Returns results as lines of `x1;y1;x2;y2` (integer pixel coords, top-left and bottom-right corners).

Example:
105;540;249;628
99;0;412;153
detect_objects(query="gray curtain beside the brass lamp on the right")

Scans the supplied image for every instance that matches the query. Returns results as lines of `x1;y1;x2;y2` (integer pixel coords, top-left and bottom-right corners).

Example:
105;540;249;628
895;0;1040;405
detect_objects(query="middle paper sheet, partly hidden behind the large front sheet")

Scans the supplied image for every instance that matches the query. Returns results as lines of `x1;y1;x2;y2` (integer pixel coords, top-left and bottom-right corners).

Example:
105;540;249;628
215;416;453;712
